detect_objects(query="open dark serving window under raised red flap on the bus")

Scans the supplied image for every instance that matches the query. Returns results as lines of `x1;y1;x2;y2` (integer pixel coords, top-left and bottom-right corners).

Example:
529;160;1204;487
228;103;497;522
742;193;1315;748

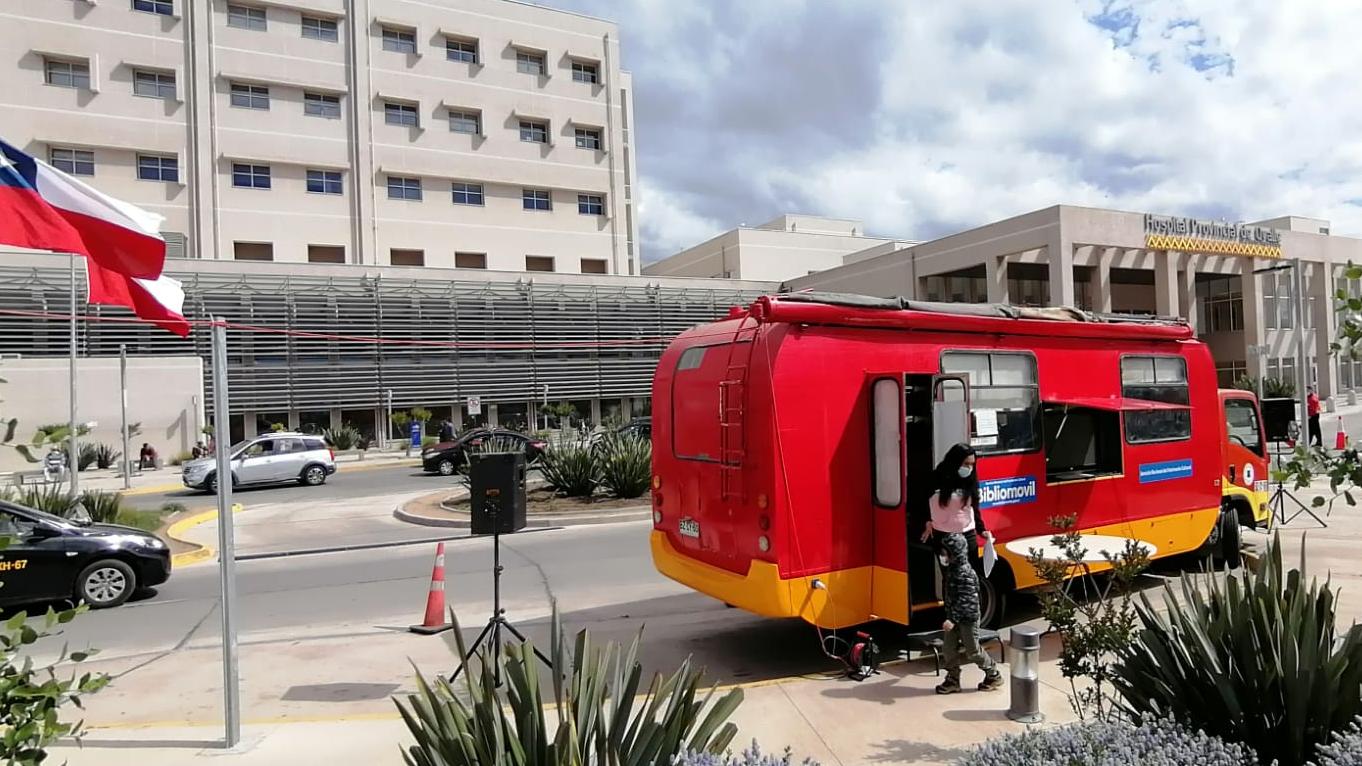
1042;402;1121;481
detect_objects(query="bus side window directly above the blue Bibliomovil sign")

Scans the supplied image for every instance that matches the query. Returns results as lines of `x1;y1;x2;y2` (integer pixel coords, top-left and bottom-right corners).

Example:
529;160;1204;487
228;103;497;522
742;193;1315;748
941;352;1041;455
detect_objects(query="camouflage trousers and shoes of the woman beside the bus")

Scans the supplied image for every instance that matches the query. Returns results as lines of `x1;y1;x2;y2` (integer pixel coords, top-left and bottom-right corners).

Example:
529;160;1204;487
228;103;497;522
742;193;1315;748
936;532;1002;694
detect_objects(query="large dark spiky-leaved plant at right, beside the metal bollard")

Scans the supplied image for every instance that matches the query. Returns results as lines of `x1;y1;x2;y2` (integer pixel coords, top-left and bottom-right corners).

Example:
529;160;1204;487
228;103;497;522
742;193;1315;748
1114;531;1362;766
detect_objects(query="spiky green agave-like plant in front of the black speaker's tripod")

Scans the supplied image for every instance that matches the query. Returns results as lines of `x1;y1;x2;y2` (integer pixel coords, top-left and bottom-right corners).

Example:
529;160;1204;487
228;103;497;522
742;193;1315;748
396;612;742;766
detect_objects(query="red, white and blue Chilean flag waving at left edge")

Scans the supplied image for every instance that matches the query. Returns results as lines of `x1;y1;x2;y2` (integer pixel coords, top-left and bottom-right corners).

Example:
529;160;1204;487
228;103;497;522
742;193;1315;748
0;140;189;337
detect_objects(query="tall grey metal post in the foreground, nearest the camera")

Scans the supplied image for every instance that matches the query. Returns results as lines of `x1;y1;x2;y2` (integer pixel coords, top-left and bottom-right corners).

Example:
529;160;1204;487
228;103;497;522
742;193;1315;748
212;316;241;748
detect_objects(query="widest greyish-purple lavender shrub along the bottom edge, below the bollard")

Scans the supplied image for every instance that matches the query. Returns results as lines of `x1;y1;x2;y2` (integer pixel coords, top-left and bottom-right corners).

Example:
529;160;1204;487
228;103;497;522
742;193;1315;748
956;718;1258;766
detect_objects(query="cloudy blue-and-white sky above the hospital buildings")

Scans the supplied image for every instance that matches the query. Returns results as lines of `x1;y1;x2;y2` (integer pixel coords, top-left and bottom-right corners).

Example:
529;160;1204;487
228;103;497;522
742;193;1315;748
541;0;1362;260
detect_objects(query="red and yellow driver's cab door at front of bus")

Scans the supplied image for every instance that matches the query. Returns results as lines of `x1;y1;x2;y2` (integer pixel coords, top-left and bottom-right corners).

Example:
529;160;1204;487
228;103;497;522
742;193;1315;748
1220;388;1271;529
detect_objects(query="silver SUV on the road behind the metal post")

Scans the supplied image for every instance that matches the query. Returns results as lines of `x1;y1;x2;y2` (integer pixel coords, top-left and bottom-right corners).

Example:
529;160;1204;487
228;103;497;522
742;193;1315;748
183;433;336;492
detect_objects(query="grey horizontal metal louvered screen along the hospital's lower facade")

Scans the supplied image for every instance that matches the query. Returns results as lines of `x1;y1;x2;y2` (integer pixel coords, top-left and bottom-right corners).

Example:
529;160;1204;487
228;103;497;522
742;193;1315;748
0;262;761;414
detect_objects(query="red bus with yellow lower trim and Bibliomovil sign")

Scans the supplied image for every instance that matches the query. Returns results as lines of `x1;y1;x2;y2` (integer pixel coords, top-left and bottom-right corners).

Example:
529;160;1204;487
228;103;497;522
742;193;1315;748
651;293;1267;628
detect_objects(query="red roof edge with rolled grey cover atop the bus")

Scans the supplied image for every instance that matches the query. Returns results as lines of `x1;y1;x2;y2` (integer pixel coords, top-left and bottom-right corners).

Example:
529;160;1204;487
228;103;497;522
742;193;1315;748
746;292;1193;341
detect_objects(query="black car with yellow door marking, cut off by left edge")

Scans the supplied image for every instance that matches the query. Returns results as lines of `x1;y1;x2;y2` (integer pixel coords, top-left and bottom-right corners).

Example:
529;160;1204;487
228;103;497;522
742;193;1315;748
0;502;170;609
